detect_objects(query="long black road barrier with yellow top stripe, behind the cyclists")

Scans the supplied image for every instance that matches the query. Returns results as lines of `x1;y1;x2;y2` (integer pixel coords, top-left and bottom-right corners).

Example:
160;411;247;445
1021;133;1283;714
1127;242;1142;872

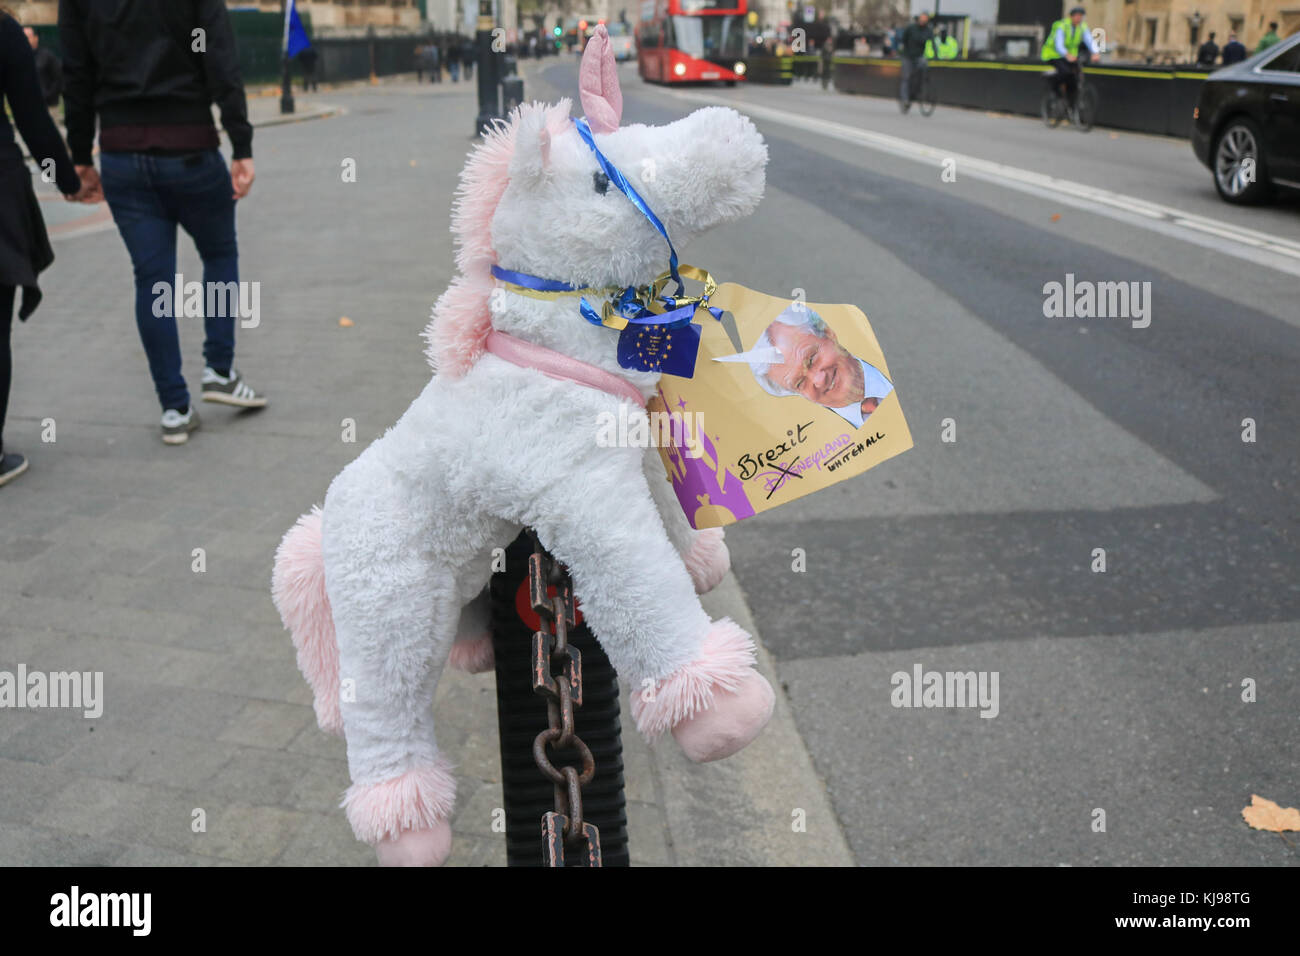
835;56;1208;137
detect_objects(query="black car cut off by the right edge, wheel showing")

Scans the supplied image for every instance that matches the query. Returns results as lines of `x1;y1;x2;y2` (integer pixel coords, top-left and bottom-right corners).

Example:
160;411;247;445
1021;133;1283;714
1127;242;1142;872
1192;34;1300;203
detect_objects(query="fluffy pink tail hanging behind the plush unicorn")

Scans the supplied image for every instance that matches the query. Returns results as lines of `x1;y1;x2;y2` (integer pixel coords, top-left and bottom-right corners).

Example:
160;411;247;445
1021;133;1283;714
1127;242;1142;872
270;506;343;736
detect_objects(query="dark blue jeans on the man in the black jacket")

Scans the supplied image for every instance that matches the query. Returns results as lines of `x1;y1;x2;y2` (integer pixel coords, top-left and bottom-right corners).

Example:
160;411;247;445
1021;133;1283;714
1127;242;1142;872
100;150;239;408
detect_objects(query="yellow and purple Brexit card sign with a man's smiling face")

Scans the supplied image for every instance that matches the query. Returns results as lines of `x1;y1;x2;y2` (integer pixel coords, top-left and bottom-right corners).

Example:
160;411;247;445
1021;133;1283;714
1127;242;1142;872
649;282;911;528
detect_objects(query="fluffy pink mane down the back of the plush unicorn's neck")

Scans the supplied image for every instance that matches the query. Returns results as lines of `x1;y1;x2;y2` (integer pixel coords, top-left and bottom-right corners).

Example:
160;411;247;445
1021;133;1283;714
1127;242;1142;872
424;99;569;378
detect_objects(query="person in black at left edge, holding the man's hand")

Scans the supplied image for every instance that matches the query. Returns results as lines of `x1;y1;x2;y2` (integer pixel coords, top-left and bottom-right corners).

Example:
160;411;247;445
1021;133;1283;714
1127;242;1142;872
0;7;91;485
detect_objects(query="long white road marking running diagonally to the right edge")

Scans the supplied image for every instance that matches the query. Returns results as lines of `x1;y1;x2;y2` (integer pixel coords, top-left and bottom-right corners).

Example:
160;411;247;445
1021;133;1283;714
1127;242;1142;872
664;90;1300;276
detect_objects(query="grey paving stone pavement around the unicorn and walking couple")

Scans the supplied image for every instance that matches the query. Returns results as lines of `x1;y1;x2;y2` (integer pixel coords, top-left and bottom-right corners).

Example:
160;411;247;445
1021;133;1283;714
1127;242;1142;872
0;72;852;865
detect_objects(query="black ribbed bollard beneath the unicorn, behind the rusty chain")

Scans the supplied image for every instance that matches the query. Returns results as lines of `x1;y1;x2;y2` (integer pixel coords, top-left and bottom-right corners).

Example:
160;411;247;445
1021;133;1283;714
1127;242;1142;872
489;533;629;866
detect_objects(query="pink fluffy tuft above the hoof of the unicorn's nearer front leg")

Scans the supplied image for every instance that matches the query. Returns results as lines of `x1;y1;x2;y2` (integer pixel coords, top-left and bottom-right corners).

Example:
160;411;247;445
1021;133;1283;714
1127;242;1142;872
632;618;755;740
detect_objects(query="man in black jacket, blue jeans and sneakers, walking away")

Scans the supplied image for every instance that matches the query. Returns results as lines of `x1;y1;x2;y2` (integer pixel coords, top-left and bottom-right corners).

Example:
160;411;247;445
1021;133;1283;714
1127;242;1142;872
59;0;267;445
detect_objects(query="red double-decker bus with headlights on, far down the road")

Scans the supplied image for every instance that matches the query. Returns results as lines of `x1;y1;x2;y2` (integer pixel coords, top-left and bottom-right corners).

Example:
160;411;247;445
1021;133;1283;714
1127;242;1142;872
637;0;748;86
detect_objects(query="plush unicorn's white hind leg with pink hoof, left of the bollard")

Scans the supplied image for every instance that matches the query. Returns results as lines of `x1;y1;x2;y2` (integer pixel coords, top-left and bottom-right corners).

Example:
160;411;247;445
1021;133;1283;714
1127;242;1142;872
322;489;460;865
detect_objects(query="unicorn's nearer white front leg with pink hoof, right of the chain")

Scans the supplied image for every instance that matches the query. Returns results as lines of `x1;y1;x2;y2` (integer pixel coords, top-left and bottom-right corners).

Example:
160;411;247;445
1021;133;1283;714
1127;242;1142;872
530;449;774;761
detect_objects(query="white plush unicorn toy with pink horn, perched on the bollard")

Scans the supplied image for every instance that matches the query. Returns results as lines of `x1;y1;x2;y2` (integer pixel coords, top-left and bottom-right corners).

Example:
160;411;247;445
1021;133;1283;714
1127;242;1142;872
272;26;774;865
